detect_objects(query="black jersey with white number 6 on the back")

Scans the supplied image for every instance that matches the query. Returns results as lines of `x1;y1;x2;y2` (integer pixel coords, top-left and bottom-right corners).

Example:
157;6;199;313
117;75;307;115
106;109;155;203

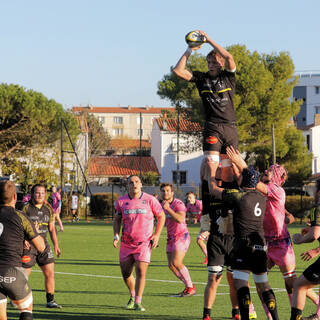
222;189;266;242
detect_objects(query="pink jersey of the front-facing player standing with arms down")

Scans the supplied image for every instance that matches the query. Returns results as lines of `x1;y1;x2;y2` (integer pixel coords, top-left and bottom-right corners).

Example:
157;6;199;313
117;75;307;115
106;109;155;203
115;192;163;244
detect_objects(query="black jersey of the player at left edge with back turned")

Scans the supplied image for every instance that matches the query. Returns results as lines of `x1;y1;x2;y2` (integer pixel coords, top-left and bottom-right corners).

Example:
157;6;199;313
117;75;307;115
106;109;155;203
0;206;38;267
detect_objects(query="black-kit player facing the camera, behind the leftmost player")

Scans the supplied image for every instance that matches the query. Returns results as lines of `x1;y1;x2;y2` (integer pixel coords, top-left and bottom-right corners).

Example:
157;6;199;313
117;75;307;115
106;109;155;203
22;184;62;308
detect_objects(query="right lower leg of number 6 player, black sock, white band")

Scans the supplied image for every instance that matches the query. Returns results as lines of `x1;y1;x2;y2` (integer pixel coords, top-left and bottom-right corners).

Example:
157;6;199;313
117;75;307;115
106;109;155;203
253;272;279;320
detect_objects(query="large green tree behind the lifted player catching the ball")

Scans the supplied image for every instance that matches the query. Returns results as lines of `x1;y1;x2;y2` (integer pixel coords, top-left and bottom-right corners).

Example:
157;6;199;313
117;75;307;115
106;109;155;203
158;45;312;180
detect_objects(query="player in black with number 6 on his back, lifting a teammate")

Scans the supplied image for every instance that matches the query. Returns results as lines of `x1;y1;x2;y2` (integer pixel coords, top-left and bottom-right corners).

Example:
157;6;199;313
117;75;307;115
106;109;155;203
209;152;279;320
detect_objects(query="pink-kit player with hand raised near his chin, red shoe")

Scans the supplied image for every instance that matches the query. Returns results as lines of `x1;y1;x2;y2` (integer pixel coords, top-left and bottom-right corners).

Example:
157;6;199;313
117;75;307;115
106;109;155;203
160;183;196;297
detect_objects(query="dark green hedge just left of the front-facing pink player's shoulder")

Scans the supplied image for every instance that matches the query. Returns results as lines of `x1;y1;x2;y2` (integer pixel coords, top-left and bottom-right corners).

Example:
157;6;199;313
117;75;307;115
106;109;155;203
90;192;119;218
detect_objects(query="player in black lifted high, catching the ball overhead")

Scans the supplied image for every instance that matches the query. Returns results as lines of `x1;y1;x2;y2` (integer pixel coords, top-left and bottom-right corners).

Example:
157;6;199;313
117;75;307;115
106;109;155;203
173;31;238;192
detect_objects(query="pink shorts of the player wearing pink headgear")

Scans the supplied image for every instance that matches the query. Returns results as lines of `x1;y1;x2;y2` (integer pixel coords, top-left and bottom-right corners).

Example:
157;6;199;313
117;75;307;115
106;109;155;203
267;238;296;267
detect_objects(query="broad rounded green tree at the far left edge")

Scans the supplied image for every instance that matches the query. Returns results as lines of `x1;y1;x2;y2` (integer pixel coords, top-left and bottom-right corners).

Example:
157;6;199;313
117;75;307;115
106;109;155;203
0;83;79;184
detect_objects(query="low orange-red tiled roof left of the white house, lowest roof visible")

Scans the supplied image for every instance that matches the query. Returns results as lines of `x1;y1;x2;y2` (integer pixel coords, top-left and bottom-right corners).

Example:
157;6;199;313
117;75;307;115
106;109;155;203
89;156;159;177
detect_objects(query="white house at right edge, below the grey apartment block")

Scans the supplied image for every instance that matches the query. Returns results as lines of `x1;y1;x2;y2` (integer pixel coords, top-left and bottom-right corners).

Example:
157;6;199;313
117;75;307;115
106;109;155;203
301;114;320;179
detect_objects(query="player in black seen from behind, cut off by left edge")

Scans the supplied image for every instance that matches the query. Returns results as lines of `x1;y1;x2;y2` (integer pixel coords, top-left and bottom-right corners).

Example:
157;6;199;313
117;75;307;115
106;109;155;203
0;180;45;320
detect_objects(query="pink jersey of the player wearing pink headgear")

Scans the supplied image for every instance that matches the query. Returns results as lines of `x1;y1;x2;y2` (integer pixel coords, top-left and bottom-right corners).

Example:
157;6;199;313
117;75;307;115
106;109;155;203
263;183;290;239
